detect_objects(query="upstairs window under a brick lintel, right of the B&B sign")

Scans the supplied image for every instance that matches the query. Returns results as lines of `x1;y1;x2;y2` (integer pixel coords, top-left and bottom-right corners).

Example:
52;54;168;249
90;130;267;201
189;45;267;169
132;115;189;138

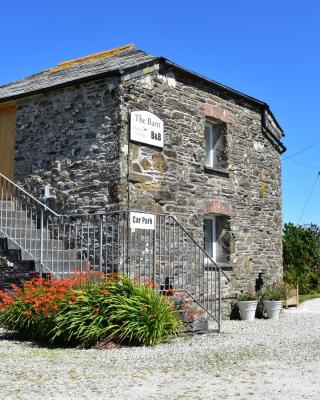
204;121;227;171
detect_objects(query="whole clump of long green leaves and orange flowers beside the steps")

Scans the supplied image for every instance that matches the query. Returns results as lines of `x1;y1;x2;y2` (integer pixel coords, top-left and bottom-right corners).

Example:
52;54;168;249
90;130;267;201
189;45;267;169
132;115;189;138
0;272;182;346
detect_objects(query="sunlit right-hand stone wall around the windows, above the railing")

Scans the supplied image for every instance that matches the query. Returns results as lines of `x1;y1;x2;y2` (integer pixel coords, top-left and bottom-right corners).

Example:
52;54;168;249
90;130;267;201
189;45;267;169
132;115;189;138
119;67;282;314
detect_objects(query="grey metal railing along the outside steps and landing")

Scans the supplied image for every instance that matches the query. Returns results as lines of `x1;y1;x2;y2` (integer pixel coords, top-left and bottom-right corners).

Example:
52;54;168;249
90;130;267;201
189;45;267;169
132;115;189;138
0;173;228;329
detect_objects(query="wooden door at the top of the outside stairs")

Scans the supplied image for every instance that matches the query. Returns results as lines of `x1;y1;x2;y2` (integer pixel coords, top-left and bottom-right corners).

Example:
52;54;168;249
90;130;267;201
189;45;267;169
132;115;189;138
0;105;16;196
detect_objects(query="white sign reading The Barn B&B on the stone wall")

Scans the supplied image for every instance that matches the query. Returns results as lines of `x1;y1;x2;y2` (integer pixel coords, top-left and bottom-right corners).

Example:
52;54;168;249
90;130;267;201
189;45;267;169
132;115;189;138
130;111;163;148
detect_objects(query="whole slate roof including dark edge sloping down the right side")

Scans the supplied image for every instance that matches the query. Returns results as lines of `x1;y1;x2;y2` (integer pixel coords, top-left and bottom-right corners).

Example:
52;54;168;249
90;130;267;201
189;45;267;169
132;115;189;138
0;44;285;149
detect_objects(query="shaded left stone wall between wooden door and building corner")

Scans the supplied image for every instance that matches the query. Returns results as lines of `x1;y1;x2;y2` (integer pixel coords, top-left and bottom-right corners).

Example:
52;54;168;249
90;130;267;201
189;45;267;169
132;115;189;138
15;79;120;212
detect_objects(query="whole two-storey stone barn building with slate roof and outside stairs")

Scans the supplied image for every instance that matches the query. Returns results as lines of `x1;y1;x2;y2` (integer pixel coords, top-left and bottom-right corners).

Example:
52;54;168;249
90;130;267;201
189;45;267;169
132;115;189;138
0;45;285;319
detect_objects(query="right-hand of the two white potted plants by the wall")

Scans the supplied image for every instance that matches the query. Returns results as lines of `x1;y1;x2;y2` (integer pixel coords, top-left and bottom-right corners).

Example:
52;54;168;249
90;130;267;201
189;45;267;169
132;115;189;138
260;282;288;319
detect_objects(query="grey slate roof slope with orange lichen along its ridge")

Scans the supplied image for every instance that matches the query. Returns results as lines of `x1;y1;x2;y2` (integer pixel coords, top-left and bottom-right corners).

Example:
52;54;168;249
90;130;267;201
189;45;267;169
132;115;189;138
0;45;158;101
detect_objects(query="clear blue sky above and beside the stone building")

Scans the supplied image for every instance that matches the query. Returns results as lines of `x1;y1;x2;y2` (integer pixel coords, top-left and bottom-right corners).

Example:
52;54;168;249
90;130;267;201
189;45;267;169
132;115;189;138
0;0;320;225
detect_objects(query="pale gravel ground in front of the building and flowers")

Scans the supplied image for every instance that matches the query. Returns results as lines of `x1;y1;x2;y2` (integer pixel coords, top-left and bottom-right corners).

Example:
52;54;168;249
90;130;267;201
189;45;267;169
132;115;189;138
0;301;320;400
